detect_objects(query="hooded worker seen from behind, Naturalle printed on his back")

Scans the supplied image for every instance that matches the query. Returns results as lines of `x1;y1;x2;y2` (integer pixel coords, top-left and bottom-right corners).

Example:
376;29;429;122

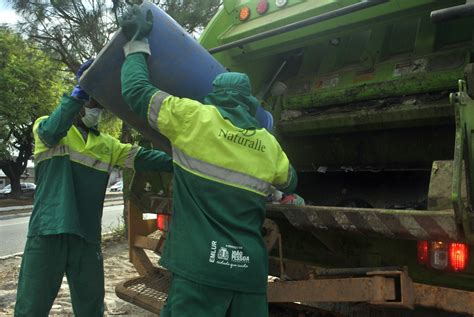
121;6;296;317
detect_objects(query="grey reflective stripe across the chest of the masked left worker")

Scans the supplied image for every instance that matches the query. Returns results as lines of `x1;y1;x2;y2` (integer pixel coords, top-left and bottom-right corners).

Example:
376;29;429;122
35;145;113;173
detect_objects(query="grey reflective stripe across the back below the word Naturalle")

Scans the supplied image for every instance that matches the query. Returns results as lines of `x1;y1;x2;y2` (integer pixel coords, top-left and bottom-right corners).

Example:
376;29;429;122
173;147;271;196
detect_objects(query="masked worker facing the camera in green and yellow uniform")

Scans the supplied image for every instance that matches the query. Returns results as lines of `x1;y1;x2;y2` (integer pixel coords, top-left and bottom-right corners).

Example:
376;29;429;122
15;62;173;317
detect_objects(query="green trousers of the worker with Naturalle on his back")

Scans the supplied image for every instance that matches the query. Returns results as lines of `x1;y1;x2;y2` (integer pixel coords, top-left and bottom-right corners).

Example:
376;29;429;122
160;274;268;317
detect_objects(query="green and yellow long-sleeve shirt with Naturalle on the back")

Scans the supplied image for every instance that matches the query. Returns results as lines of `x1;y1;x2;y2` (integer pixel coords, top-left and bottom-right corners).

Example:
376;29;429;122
122;53;296;293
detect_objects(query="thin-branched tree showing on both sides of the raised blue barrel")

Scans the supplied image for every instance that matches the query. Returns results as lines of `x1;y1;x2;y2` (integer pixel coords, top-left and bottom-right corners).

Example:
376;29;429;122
9;0;222;73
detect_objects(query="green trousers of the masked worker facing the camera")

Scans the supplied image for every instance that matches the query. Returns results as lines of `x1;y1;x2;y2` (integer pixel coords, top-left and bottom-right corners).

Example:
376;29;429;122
15;234;105;317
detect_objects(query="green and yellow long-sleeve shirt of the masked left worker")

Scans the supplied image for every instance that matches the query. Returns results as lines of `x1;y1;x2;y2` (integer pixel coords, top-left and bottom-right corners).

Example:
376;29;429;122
28;96;173;243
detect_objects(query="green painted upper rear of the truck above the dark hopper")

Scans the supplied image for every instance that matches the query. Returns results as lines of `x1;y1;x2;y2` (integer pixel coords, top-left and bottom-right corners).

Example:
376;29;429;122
200;0;474;128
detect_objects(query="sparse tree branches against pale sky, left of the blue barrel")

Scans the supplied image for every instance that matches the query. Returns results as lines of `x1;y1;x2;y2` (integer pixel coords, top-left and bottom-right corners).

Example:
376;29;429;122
10;0;117;73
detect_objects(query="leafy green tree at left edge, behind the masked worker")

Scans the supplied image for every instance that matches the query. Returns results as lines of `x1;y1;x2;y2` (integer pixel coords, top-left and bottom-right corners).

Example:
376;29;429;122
0;27;64;195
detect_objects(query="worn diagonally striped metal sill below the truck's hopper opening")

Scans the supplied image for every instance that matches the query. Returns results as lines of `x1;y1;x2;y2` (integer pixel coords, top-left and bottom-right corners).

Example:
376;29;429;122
267;204;464;241
